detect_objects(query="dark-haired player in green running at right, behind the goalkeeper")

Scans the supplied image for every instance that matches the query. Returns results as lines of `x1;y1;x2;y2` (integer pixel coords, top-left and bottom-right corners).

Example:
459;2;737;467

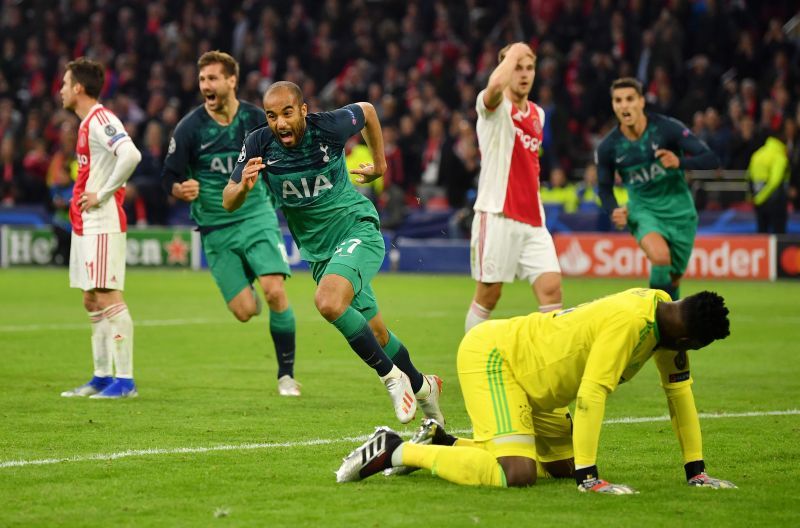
595;77;719;299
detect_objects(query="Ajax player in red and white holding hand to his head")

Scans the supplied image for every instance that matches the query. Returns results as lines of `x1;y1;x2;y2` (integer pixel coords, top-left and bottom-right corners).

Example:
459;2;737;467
464;42;561;331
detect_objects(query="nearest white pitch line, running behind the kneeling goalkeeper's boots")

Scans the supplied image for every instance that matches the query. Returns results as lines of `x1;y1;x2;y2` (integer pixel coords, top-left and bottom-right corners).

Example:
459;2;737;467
0;409;800;469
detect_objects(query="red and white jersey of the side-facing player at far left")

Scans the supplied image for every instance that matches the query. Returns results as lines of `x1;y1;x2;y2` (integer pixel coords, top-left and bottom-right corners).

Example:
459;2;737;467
69;104;131;235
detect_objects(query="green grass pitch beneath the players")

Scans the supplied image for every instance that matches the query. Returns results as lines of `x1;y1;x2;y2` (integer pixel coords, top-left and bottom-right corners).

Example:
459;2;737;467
0;269;800;528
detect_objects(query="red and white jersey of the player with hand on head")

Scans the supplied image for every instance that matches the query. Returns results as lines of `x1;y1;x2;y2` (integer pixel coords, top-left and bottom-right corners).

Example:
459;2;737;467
475;90;544;227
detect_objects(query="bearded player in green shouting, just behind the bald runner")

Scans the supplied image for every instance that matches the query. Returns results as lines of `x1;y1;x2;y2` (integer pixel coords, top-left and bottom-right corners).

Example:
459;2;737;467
163;51;300;396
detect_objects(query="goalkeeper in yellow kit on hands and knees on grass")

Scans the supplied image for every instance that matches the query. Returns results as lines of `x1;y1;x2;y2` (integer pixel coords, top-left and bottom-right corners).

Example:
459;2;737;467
336;289;735;494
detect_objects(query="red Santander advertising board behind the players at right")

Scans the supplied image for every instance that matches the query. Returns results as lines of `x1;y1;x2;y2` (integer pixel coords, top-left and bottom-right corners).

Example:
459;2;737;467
553;233;774;279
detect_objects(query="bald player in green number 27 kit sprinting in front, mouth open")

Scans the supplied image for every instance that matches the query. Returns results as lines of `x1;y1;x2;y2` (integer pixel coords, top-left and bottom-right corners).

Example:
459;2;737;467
223;81;443;423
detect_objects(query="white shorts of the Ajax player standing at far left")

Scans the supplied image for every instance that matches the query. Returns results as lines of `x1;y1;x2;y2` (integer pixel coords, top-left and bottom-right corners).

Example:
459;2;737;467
69;231;126;291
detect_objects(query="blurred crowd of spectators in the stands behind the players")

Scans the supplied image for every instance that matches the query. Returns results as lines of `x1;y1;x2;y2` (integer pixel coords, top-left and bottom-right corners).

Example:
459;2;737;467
0;0;800;227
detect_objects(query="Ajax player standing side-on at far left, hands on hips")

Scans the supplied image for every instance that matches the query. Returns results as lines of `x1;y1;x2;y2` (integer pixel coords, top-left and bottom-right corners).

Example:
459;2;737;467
61;58;142;398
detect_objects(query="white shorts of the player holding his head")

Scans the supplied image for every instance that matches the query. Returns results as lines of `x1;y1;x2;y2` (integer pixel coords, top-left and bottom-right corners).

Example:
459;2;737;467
470;211;561;284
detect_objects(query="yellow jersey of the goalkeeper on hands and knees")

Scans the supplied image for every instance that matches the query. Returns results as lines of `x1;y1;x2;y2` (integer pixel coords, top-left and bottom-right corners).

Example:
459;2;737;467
495;288;691;410
